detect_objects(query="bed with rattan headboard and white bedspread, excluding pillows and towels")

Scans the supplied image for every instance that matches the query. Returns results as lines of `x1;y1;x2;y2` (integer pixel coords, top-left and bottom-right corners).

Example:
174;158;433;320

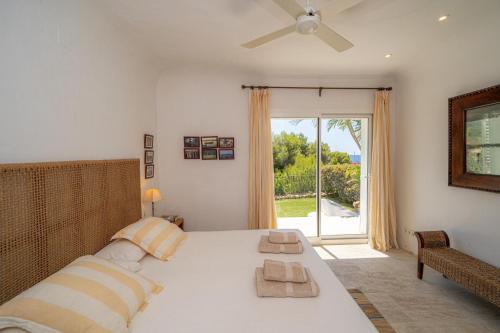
0;159;376;333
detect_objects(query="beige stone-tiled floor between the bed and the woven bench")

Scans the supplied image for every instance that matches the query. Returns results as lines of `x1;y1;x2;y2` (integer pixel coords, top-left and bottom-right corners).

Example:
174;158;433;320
315;245;500;333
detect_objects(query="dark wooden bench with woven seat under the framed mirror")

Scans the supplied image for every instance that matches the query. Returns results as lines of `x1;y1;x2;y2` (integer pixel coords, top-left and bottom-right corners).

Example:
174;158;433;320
415;231;500;307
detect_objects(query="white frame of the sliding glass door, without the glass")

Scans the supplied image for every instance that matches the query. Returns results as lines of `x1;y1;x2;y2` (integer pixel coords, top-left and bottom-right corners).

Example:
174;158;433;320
271;113;373;241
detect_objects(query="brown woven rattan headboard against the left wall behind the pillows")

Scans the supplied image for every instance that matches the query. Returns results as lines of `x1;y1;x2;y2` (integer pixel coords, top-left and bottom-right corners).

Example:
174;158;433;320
0;159;141;304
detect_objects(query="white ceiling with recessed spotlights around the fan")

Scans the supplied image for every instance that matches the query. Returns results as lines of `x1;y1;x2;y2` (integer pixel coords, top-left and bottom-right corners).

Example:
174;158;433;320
101;0;500;75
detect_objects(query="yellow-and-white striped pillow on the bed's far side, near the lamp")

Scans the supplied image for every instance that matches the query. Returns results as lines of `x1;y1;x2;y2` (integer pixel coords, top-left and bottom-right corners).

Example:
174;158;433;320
111;217;186;260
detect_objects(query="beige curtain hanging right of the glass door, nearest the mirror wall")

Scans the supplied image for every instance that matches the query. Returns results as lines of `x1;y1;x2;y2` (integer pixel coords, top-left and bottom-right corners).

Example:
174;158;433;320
369;91;398;251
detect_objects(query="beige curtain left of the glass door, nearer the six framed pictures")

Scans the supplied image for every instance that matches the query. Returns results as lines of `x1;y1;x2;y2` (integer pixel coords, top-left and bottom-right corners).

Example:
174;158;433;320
248;89;277;229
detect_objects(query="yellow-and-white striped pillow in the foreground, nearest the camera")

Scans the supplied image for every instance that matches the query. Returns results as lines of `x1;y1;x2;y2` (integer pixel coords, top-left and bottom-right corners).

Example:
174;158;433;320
0;256;162;333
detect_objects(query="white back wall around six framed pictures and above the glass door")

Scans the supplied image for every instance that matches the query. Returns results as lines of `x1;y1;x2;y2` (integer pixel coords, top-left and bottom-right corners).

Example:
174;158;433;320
157;66;392;230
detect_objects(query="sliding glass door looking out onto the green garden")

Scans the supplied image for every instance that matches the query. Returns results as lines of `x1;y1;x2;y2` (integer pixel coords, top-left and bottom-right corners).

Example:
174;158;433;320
272;115;371;238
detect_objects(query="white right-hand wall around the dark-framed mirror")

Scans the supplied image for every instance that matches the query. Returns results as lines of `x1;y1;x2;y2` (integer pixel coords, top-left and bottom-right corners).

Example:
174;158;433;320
396;9;500;266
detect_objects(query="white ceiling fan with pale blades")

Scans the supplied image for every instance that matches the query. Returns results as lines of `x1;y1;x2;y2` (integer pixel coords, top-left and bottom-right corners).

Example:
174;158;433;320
242;0;364;52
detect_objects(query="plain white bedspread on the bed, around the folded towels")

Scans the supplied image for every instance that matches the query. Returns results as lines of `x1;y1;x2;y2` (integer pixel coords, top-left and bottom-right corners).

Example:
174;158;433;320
131;230;377;333
